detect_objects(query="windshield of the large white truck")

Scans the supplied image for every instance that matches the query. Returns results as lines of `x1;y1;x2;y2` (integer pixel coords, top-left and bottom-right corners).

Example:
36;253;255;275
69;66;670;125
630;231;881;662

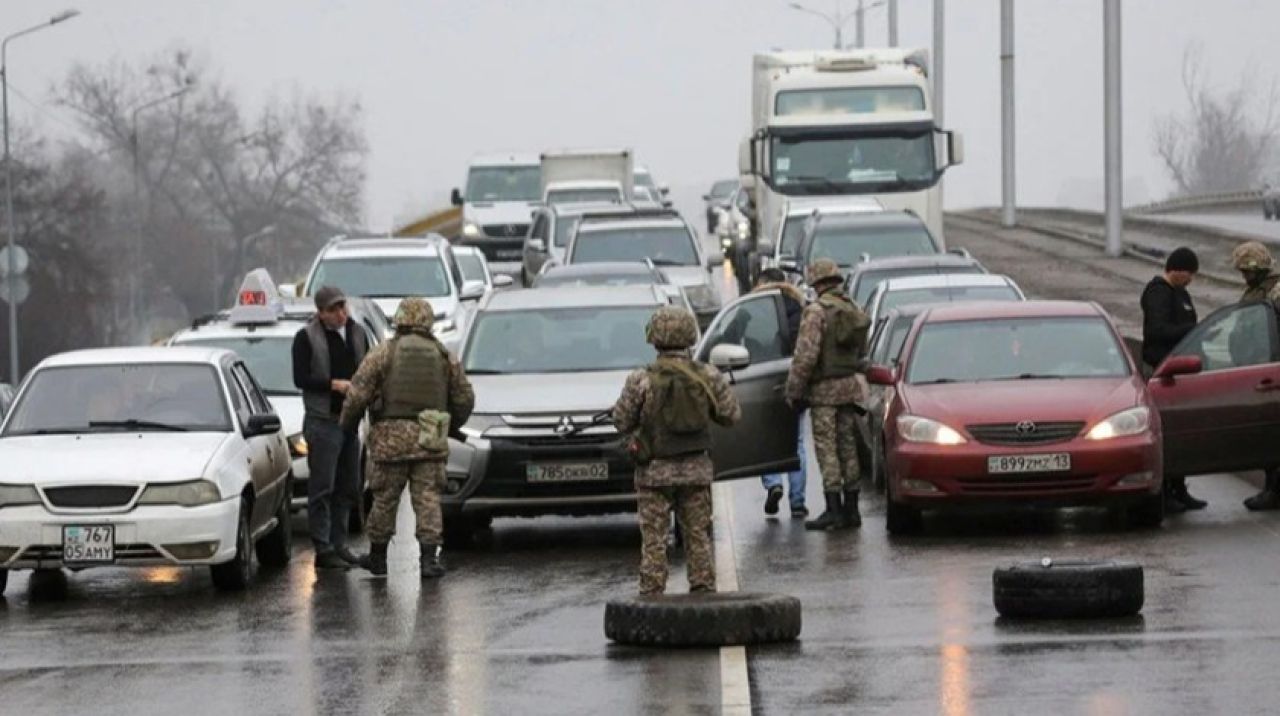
772;131;938;195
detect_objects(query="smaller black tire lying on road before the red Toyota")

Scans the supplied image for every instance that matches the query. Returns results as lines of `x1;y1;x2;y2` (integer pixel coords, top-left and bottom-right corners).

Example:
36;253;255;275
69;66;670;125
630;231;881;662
992;561;1144;619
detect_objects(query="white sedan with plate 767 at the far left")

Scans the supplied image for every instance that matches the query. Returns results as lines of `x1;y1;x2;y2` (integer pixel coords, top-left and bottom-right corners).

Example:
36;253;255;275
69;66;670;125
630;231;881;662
0;347;291;593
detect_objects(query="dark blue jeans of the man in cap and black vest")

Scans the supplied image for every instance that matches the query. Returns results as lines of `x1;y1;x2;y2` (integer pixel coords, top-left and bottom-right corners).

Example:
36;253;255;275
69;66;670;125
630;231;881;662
302;418;360;553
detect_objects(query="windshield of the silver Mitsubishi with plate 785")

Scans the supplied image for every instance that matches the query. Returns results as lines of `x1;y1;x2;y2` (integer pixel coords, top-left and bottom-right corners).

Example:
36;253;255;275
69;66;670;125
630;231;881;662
463;306;657;375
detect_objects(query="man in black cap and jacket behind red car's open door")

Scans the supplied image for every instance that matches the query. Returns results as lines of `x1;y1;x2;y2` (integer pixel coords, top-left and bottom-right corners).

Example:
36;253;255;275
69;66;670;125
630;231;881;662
1140;246;1207;514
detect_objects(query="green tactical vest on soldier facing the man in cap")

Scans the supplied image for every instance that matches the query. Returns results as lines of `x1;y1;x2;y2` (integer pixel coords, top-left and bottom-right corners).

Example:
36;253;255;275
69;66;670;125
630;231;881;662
374;333;449;420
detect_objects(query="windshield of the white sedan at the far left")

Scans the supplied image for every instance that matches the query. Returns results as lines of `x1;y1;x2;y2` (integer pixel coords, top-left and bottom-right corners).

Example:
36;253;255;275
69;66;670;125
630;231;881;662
4;362;232;437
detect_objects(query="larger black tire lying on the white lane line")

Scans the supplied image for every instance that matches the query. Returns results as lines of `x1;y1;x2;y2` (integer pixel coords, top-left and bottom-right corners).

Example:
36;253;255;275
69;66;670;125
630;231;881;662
604;592;801;647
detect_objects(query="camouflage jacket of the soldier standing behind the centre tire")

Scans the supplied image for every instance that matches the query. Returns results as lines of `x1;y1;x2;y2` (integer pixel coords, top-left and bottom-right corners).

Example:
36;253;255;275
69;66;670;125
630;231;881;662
613;351;742;488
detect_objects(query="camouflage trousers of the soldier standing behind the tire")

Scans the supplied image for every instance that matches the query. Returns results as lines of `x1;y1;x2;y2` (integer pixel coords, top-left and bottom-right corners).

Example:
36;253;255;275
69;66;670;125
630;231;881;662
636;485;716;596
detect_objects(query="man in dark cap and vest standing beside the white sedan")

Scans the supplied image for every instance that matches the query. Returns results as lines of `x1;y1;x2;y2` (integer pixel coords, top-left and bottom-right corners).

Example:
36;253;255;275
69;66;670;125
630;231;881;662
293;286;369;569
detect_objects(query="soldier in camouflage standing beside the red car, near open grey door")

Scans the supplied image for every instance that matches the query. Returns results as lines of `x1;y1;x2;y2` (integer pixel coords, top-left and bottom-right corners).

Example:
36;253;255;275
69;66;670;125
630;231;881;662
786;259;870;530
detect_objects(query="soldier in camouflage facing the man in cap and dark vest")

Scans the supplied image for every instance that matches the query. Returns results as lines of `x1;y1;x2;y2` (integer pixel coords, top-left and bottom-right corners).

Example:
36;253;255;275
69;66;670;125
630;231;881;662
340;298;475;578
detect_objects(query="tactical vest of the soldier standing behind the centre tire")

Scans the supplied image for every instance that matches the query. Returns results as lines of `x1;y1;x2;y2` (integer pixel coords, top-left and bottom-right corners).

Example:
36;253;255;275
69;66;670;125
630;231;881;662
645;359;714;459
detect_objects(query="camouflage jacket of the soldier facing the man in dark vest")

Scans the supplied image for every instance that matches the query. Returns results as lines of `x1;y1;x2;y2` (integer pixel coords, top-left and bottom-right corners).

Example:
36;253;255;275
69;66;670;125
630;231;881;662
339;341;476;462
